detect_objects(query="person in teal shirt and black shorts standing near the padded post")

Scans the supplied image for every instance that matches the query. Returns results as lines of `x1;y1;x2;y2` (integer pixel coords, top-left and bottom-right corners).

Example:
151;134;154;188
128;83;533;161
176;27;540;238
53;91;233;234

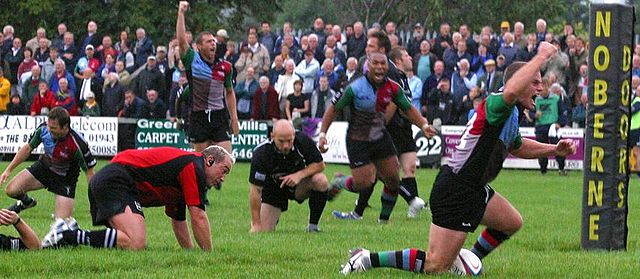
535;79;566;175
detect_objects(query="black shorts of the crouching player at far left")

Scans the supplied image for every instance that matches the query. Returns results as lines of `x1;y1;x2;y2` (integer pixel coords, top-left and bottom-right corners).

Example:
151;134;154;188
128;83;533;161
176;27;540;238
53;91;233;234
27;160;80;199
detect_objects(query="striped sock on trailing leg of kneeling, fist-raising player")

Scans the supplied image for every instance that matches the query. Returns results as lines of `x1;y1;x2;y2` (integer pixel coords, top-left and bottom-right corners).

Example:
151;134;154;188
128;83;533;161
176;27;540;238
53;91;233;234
371;249;427;273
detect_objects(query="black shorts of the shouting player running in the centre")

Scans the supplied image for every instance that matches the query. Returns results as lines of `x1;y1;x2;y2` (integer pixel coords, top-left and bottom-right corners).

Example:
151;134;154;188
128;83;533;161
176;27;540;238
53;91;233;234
347;131;397;169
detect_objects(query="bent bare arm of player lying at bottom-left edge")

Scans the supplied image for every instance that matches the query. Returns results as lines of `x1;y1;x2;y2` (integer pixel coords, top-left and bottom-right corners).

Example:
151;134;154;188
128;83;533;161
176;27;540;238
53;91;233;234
0;209;40;251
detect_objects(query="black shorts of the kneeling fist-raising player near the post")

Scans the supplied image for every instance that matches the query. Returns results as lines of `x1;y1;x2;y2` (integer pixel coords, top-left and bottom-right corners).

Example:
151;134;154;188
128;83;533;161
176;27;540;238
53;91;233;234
429;165;495;232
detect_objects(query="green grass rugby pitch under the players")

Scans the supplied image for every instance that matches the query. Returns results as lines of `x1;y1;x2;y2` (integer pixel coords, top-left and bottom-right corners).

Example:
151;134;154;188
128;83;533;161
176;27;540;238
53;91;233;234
0;161;640;278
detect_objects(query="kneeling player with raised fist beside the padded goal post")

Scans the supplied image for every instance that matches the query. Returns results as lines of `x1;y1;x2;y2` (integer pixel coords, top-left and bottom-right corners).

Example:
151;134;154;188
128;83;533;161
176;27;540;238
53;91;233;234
342;42;576;274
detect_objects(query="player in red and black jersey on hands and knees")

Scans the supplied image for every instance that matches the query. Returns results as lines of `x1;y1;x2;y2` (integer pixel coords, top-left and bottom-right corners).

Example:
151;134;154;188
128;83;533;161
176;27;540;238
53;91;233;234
43;145;234;251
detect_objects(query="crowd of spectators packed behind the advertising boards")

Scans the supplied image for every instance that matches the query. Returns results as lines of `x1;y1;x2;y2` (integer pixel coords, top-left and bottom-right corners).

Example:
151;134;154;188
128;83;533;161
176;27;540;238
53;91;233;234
0;18;640;133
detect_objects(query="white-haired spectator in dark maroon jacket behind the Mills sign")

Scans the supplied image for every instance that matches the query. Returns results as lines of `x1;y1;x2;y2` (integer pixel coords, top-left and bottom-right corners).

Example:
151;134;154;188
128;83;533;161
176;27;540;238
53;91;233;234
251;76;280;121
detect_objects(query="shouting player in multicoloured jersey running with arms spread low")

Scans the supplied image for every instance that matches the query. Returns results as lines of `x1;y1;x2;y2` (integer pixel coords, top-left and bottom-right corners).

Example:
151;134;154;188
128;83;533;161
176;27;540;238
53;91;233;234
319;52;435;221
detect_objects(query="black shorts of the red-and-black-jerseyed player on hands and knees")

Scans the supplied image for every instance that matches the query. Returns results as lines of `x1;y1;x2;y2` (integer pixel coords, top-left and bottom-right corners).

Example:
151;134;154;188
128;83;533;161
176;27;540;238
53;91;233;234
89;164;144;226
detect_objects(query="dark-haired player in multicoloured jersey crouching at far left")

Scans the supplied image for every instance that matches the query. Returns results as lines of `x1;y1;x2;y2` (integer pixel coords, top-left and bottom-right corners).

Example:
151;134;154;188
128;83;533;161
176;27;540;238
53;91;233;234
0;107;96;247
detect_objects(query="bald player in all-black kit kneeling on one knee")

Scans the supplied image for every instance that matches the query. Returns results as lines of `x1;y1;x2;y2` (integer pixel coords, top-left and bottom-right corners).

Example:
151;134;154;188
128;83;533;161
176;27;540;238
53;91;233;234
249;120;329;232
